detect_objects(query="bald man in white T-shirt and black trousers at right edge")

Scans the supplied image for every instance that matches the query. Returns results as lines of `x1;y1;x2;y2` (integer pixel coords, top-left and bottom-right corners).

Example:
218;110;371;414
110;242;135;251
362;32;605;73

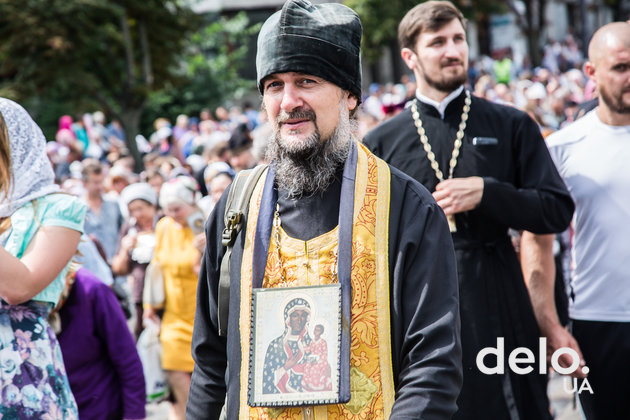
548;22;630;420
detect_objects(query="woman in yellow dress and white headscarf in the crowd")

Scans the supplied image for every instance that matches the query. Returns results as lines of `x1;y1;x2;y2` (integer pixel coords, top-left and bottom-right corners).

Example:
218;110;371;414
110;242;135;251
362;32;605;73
145;176;206;420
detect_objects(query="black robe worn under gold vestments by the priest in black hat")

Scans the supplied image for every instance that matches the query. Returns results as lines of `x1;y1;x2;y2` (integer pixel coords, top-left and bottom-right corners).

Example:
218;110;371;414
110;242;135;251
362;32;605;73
186;156;462;420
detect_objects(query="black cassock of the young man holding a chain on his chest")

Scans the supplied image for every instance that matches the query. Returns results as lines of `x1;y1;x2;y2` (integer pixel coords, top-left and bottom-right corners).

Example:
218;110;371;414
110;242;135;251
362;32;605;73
364;92;574;420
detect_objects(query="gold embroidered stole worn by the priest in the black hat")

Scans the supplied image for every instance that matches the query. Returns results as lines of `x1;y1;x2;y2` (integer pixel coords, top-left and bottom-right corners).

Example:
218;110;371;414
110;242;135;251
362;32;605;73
239;144;395;420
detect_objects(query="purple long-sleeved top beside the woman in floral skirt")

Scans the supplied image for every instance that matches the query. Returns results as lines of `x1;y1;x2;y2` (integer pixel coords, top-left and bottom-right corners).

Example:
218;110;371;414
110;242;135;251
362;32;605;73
58;268;146;420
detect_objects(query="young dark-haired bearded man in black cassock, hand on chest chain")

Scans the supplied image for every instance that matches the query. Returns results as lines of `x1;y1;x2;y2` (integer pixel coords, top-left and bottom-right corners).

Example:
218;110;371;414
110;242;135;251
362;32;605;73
364;1;573;420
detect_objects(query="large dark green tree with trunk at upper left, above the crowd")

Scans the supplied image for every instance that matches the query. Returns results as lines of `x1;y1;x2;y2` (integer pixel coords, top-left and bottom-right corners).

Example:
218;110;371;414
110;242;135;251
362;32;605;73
0;0;200;169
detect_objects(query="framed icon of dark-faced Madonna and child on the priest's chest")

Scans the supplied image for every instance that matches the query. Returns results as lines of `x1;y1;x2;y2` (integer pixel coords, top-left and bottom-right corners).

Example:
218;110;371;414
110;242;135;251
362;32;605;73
247;283;350;411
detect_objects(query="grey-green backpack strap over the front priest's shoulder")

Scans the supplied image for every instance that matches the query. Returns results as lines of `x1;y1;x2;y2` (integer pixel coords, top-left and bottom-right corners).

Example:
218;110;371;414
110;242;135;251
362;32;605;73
218;165;267;337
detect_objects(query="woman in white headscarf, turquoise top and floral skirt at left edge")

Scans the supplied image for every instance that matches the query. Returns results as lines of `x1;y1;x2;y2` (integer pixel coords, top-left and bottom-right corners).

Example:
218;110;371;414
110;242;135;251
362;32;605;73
0;98;86;419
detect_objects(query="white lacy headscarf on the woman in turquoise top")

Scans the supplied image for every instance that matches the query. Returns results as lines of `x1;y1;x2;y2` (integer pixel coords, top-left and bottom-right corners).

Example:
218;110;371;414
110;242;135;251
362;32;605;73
0;98;59;217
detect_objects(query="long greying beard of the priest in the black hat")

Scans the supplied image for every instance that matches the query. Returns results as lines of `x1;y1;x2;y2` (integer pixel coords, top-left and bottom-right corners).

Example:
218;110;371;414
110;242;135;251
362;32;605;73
266;100;356;198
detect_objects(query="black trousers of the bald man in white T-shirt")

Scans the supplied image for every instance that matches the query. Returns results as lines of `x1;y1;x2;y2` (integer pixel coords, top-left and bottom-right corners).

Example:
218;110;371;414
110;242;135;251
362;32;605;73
572;320;630;420
